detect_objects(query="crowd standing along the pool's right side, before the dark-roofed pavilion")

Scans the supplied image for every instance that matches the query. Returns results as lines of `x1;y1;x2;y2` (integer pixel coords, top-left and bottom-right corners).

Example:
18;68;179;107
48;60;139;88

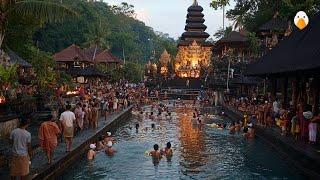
226;97;320;144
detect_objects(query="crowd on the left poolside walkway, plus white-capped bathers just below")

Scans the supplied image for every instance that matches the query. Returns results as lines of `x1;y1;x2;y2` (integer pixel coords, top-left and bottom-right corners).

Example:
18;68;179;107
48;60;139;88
10;81;150;179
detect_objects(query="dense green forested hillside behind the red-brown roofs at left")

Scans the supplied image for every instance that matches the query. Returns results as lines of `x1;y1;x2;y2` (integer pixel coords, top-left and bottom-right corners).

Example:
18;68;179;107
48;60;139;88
34;0;177;62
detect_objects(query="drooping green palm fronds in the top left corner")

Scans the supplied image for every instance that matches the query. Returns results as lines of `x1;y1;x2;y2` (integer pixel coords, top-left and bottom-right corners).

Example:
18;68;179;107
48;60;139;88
0;0;77;48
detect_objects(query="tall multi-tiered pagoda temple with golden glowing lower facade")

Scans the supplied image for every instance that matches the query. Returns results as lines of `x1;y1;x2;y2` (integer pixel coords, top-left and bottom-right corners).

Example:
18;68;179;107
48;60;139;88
174;0;213;78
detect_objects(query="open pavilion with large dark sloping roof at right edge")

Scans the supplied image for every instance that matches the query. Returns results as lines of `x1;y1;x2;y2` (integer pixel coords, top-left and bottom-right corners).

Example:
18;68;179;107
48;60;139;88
247;13;320;112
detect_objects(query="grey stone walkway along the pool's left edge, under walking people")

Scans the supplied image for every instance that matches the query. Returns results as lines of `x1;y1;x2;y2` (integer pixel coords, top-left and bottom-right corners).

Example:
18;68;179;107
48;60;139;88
0;109;127;179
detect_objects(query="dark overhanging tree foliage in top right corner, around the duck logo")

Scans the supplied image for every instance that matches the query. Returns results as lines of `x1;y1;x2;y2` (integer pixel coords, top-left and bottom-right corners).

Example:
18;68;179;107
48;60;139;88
227;0;320;32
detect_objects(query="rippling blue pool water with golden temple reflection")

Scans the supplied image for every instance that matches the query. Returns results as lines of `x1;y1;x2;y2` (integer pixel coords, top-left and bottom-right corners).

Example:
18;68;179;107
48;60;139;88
59;106;304;180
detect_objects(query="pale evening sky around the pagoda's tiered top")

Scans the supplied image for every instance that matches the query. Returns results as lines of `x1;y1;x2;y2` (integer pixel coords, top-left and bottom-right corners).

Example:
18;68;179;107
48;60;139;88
104;0;235;39
